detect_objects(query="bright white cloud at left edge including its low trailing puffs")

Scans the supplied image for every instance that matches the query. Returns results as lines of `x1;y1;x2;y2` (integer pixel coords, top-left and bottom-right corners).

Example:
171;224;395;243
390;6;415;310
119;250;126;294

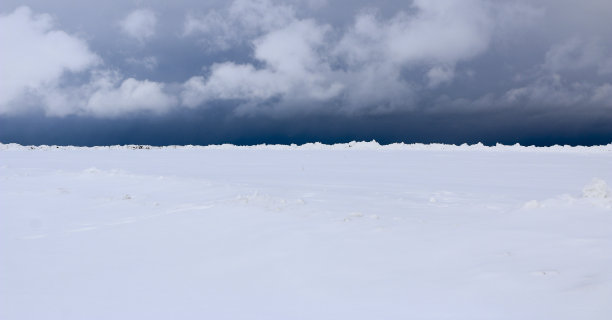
0;7;177;117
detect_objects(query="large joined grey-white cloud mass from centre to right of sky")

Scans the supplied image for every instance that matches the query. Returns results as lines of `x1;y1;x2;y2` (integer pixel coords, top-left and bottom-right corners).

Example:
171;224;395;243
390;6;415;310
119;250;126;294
182;0;500;113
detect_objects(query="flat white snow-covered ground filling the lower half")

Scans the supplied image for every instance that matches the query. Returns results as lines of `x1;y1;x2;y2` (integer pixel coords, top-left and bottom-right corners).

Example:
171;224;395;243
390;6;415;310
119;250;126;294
0;143;612;320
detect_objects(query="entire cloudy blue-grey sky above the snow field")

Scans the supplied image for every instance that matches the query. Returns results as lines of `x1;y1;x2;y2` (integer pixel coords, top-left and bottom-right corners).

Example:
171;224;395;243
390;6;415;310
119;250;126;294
0;0;612;145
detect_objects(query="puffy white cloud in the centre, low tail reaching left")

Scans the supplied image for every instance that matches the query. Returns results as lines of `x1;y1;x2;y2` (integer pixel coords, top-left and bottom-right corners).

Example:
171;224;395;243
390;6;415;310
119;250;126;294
182;20;342;114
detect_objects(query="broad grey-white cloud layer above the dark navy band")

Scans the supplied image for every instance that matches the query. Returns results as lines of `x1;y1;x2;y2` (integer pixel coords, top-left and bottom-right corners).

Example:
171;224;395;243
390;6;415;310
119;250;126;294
0;0;612;118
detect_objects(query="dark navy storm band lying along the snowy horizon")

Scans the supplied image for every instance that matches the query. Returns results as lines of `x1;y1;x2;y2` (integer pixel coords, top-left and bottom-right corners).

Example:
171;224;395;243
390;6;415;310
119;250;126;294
0;106;612;146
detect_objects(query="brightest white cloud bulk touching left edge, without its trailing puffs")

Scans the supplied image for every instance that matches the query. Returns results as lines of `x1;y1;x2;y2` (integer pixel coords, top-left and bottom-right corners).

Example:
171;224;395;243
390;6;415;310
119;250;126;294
0;7;100;114
